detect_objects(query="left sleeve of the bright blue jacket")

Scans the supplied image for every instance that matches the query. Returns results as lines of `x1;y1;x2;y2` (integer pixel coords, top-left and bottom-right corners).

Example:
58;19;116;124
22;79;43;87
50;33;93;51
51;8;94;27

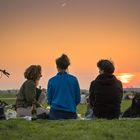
47;81;53;105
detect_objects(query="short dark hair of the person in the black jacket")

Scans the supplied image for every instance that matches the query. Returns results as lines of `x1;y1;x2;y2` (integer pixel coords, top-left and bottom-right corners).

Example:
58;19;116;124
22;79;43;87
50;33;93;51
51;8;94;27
97;59;115;74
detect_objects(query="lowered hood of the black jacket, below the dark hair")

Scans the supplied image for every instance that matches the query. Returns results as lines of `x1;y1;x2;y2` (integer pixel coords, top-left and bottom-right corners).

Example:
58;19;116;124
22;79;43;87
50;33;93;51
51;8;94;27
95;74;117;85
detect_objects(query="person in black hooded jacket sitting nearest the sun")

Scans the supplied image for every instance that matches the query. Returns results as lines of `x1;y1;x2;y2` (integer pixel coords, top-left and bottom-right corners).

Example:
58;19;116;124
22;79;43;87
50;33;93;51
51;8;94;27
89;59;123;119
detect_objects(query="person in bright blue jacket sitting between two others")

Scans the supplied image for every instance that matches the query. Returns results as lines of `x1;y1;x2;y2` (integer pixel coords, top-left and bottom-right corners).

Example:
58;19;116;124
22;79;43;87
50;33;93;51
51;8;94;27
48;54;81;120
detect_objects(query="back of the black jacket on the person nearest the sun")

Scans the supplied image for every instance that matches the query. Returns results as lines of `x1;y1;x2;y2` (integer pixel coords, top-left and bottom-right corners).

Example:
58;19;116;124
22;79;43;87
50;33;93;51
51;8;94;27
91;74;122;119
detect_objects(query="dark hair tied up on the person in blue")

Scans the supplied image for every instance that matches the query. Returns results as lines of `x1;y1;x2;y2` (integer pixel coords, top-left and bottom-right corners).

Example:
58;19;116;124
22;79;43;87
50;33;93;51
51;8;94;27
56;54;70;70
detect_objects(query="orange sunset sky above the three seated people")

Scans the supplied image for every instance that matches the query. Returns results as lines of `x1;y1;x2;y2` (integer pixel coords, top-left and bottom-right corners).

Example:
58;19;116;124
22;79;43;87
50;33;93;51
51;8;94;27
0;0;140;89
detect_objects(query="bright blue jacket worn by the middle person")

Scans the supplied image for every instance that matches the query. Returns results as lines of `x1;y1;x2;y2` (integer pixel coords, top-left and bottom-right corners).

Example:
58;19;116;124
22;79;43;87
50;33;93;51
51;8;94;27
48;72;80;112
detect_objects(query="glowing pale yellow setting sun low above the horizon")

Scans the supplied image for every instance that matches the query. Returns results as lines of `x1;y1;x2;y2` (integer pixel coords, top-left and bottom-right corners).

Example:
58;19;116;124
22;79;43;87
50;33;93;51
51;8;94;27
117;73;135;84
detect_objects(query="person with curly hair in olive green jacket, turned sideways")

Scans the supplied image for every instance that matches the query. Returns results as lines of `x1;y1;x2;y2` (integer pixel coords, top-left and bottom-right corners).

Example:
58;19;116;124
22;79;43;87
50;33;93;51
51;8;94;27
16;65;48;117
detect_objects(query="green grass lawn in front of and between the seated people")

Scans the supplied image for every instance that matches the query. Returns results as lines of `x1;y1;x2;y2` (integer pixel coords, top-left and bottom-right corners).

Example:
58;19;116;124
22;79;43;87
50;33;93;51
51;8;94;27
0;94;140;140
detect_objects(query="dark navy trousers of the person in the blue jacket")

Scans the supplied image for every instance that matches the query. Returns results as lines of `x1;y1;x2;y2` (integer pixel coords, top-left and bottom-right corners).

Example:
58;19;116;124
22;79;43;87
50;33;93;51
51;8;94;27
49;108;77;120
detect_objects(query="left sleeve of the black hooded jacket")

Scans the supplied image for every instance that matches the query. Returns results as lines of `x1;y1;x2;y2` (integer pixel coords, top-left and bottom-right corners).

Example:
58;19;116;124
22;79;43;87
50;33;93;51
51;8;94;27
89;81;95;107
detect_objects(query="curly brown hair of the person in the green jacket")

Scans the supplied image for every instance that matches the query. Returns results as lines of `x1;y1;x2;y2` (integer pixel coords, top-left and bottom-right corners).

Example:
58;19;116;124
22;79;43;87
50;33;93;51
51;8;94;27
24;65;42;81
